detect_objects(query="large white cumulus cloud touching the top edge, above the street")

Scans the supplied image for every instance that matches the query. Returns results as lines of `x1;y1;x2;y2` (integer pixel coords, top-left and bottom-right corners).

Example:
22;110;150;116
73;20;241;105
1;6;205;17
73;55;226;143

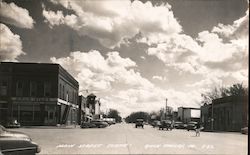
43;0;182;48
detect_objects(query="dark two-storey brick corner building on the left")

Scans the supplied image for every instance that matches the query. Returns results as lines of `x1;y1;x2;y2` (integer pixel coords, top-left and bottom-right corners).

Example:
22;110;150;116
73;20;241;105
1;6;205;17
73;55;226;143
0;62;79;125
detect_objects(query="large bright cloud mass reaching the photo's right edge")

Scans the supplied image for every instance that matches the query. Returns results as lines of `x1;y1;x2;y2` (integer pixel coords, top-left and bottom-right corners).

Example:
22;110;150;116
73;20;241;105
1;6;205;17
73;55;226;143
145;7;249;87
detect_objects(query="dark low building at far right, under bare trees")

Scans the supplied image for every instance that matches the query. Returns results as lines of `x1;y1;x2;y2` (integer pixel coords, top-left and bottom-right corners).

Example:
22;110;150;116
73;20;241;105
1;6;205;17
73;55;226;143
201;96;249;131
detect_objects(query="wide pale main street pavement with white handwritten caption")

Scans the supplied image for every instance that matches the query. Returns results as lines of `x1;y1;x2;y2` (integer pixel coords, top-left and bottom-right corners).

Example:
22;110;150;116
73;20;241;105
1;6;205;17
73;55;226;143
9;123;248;155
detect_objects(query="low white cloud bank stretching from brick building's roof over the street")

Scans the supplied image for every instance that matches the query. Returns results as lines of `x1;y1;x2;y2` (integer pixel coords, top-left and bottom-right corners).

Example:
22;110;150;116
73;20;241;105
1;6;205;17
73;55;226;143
51;50;203;116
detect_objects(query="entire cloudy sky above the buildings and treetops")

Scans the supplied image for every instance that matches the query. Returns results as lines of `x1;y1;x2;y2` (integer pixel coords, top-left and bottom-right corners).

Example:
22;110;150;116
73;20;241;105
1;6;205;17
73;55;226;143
0;0;249;116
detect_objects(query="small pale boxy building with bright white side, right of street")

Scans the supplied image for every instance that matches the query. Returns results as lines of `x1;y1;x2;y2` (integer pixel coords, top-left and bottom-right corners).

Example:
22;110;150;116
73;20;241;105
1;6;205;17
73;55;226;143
177;107;200;123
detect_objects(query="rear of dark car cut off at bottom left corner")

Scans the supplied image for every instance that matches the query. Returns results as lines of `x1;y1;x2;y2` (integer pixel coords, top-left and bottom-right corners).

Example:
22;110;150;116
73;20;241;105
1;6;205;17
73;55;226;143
0;125;41;155
